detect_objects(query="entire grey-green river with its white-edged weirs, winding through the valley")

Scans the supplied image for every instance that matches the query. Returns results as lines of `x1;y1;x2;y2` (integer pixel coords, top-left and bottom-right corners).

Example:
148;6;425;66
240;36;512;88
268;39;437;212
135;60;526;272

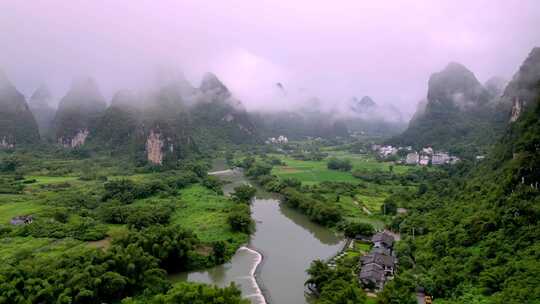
173;160;343;304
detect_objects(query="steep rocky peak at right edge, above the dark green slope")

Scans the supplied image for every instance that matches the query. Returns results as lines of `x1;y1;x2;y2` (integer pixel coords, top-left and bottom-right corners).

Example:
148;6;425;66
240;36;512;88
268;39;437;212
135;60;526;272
501;47;540;122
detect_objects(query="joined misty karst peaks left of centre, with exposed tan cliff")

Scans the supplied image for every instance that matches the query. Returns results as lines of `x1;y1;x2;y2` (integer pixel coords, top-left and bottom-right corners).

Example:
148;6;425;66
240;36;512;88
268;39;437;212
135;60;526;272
60;73;259;164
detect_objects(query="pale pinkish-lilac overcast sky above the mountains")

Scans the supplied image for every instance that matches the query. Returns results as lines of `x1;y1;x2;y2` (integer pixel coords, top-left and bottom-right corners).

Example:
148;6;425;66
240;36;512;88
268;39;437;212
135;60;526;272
0;0;540;112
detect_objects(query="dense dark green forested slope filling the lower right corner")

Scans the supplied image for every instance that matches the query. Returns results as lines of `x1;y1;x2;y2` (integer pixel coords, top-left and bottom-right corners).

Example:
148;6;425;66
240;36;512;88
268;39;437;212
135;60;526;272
381;101;540;303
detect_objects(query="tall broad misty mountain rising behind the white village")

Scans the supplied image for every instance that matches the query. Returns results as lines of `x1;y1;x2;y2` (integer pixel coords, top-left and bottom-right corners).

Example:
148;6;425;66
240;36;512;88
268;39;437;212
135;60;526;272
392;62;504;154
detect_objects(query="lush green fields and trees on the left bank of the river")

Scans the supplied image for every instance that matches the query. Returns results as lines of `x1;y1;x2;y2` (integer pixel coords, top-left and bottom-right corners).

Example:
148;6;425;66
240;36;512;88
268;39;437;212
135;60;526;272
0;150;251;304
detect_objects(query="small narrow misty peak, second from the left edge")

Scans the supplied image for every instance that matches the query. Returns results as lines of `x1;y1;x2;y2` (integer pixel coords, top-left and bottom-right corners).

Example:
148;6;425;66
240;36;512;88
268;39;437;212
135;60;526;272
28;85;56;137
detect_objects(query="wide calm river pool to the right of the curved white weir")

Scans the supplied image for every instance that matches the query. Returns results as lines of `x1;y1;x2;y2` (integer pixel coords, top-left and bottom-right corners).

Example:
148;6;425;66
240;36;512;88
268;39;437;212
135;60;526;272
251;199;341;304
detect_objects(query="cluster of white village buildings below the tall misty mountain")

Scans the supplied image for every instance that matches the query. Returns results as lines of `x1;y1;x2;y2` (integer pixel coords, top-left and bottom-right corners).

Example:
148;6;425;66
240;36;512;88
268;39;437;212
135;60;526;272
371;145;460;166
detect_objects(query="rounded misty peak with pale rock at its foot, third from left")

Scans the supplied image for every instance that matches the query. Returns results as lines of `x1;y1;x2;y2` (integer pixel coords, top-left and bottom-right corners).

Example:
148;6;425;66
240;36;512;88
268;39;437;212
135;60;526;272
54;78;107;147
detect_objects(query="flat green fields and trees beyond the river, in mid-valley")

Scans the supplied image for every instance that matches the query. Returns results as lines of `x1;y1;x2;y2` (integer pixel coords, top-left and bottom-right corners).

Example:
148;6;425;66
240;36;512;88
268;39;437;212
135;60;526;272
229;147;432;230
